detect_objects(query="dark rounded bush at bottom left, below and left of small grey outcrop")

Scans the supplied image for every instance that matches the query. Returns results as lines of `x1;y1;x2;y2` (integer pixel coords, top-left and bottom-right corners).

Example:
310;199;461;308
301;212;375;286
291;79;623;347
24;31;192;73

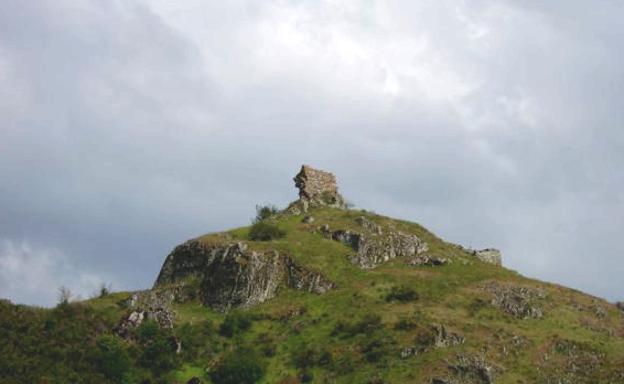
91;335;132;383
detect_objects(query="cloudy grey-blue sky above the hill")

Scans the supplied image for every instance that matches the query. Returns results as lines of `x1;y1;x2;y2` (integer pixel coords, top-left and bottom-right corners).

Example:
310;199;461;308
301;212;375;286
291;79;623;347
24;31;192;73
0;0;624;306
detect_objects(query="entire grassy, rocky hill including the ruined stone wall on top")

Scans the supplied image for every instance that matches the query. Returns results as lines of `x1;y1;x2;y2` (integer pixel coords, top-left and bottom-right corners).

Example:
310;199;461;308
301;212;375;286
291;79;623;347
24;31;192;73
0;166;624;384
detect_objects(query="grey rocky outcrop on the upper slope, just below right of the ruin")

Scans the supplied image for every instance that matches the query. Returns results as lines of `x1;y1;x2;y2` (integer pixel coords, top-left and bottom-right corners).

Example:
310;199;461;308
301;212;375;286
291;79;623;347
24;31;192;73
319;225;429;268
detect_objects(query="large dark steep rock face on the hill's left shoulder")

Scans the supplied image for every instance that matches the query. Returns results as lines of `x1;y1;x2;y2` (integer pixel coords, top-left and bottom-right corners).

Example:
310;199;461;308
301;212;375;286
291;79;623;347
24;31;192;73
155;241;334;311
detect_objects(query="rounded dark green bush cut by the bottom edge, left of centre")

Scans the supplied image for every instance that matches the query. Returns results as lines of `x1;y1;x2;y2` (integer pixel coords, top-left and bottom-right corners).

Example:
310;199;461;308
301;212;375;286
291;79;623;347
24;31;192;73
210;349;265;384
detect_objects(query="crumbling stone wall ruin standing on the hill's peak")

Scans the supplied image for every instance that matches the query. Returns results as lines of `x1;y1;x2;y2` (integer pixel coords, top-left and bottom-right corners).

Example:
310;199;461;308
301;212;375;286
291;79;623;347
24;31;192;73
294;165;345;212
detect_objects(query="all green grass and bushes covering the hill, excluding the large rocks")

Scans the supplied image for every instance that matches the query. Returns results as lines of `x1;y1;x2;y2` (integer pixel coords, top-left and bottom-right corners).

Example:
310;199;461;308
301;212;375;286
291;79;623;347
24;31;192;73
0;208;624;384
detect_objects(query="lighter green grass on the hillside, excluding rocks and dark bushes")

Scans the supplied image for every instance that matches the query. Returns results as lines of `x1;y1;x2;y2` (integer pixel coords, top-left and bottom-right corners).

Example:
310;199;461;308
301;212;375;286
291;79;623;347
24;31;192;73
0;209;624;384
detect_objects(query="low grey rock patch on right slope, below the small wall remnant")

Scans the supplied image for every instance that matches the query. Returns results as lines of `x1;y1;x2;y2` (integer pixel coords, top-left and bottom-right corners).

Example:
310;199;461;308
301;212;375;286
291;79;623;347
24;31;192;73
486;284;546;319
